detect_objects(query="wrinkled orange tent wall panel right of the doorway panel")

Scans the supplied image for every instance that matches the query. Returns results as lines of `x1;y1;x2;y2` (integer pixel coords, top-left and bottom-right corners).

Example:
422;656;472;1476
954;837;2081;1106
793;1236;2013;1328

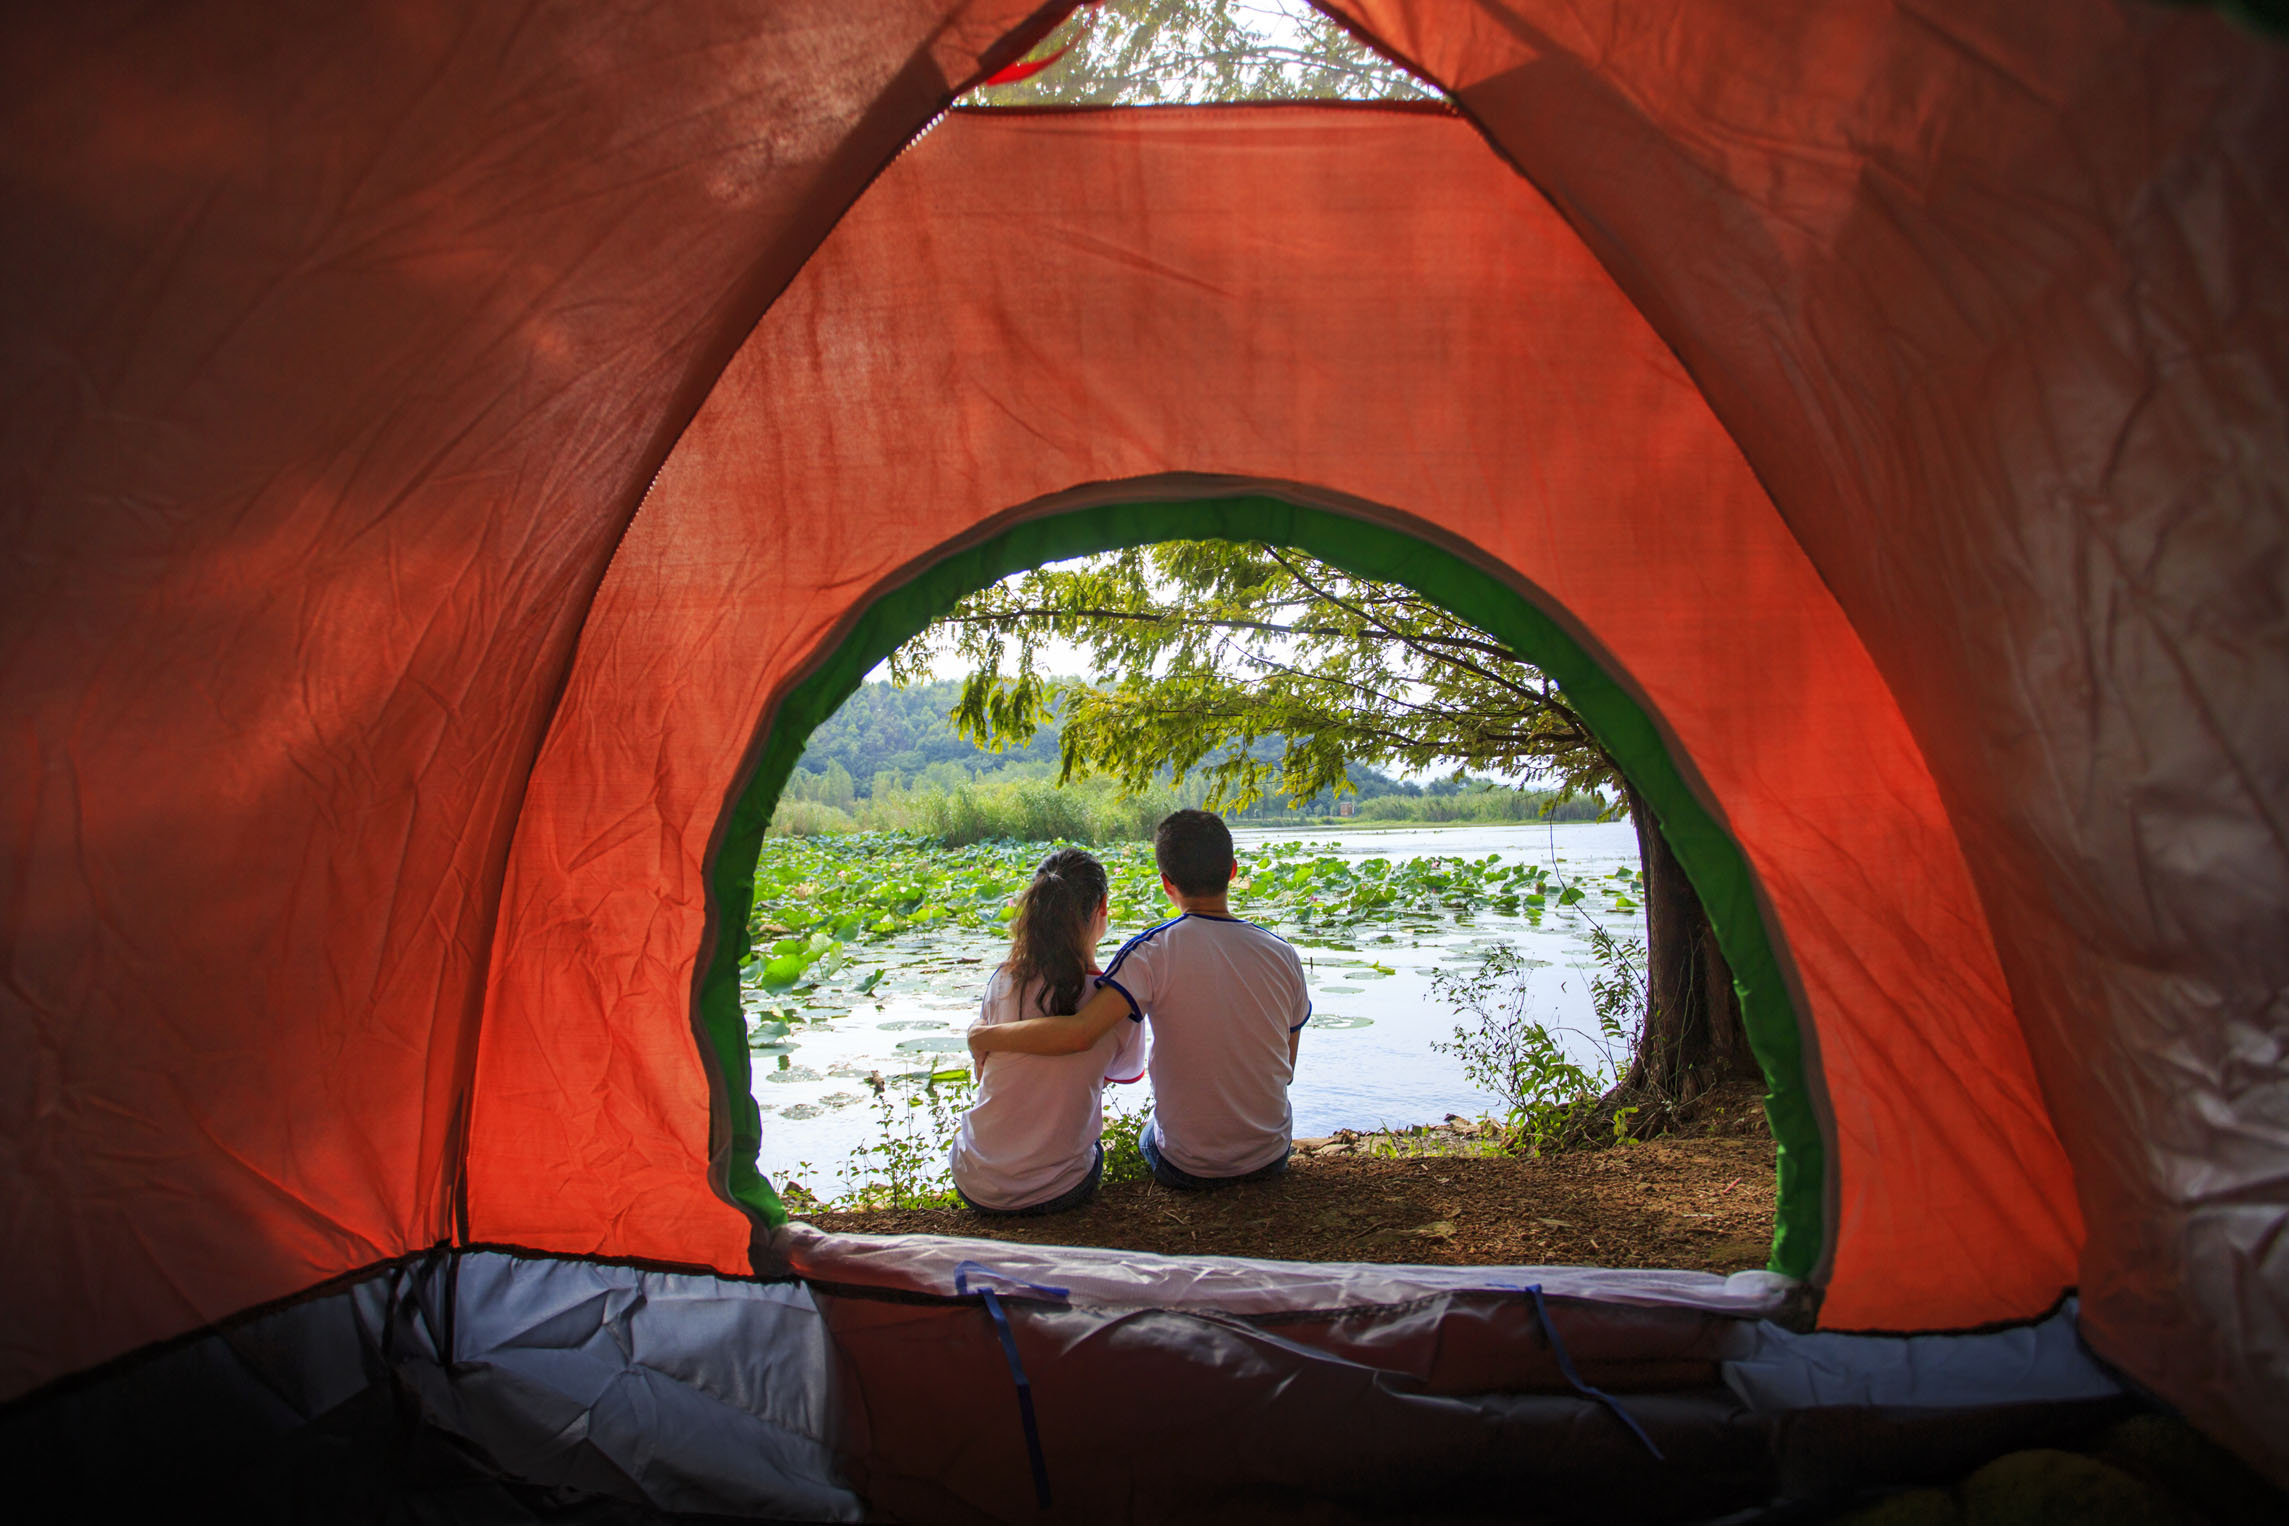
1323;0;2289;1478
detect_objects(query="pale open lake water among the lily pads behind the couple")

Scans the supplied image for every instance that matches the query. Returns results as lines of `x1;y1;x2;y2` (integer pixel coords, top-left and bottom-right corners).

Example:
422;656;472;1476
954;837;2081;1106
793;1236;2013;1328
753;821;1646;1197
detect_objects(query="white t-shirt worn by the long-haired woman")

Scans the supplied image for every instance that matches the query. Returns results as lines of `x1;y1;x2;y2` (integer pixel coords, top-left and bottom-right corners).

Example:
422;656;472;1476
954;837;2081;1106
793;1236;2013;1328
948;970;1145;1208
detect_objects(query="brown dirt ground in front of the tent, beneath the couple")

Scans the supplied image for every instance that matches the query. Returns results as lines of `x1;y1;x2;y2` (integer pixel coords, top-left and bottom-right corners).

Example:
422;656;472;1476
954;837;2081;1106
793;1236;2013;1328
801;1135;1774;1272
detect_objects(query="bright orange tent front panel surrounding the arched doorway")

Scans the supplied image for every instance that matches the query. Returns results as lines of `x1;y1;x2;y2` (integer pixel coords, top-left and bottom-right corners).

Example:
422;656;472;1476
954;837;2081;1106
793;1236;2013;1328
472;108;2081;1327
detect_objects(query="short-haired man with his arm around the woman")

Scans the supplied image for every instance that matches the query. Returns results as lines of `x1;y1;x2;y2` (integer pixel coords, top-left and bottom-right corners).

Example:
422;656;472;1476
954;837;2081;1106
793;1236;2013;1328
971;810;1312;1190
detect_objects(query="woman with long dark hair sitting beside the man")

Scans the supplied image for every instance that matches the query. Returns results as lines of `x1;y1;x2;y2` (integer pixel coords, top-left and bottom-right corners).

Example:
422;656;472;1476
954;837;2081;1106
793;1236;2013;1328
948;849;1145;1215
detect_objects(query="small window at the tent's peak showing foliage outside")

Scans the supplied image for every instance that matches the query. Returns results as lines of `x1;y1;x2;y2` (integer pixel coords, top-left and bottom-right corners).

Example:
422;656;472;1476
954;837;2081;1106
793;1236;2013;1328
973;0;1435;105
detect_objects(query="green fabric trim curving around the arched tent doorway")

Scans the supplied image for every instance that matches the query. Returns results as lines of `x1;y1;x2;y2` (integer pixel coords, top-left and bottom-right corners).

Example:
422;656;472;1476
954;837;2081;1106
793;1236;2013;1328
700;496;1827;1277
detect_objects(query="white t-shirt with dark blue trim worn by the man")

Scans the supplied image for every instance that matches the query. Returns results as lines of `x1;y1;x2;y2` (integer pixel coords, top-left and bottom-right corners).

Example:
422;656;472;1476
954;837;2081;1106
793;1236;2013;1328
1096;911;1312;1176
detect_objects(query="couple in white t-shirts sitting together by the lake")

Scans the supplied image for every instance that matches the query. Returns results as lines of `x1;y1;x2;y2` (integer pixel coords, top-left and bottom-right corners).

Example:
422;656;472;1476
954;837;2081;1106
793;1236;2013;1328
950;810;1312;1215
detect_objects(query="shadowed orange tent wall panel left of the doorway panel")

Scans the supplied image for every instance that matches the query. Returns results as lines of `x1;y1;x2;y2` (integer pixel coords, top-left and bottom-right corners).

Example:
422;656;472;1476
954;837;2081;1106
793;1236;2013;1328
0;0;1057;1398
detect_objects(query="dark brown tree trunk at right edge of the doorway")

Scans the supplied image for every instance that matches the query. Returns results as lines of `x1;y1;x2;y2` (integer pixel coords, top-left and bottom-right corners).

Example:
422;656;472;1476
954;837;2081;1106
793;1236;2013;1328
1621;785;1763;1102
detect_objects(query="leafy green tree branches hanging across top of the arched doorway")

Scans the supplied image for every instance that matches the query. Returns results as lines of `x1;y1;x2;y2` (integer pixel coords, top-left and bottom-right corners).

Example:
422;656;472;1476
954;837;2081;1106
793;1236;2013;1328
893;540;1621;812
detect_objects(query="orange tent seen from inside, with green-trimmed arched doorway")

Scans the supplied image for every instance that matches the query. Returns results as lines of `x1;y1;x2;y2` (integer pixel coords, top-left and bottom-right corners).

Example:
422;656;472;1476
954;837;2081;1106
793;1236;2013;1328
0;0;2289;1519
